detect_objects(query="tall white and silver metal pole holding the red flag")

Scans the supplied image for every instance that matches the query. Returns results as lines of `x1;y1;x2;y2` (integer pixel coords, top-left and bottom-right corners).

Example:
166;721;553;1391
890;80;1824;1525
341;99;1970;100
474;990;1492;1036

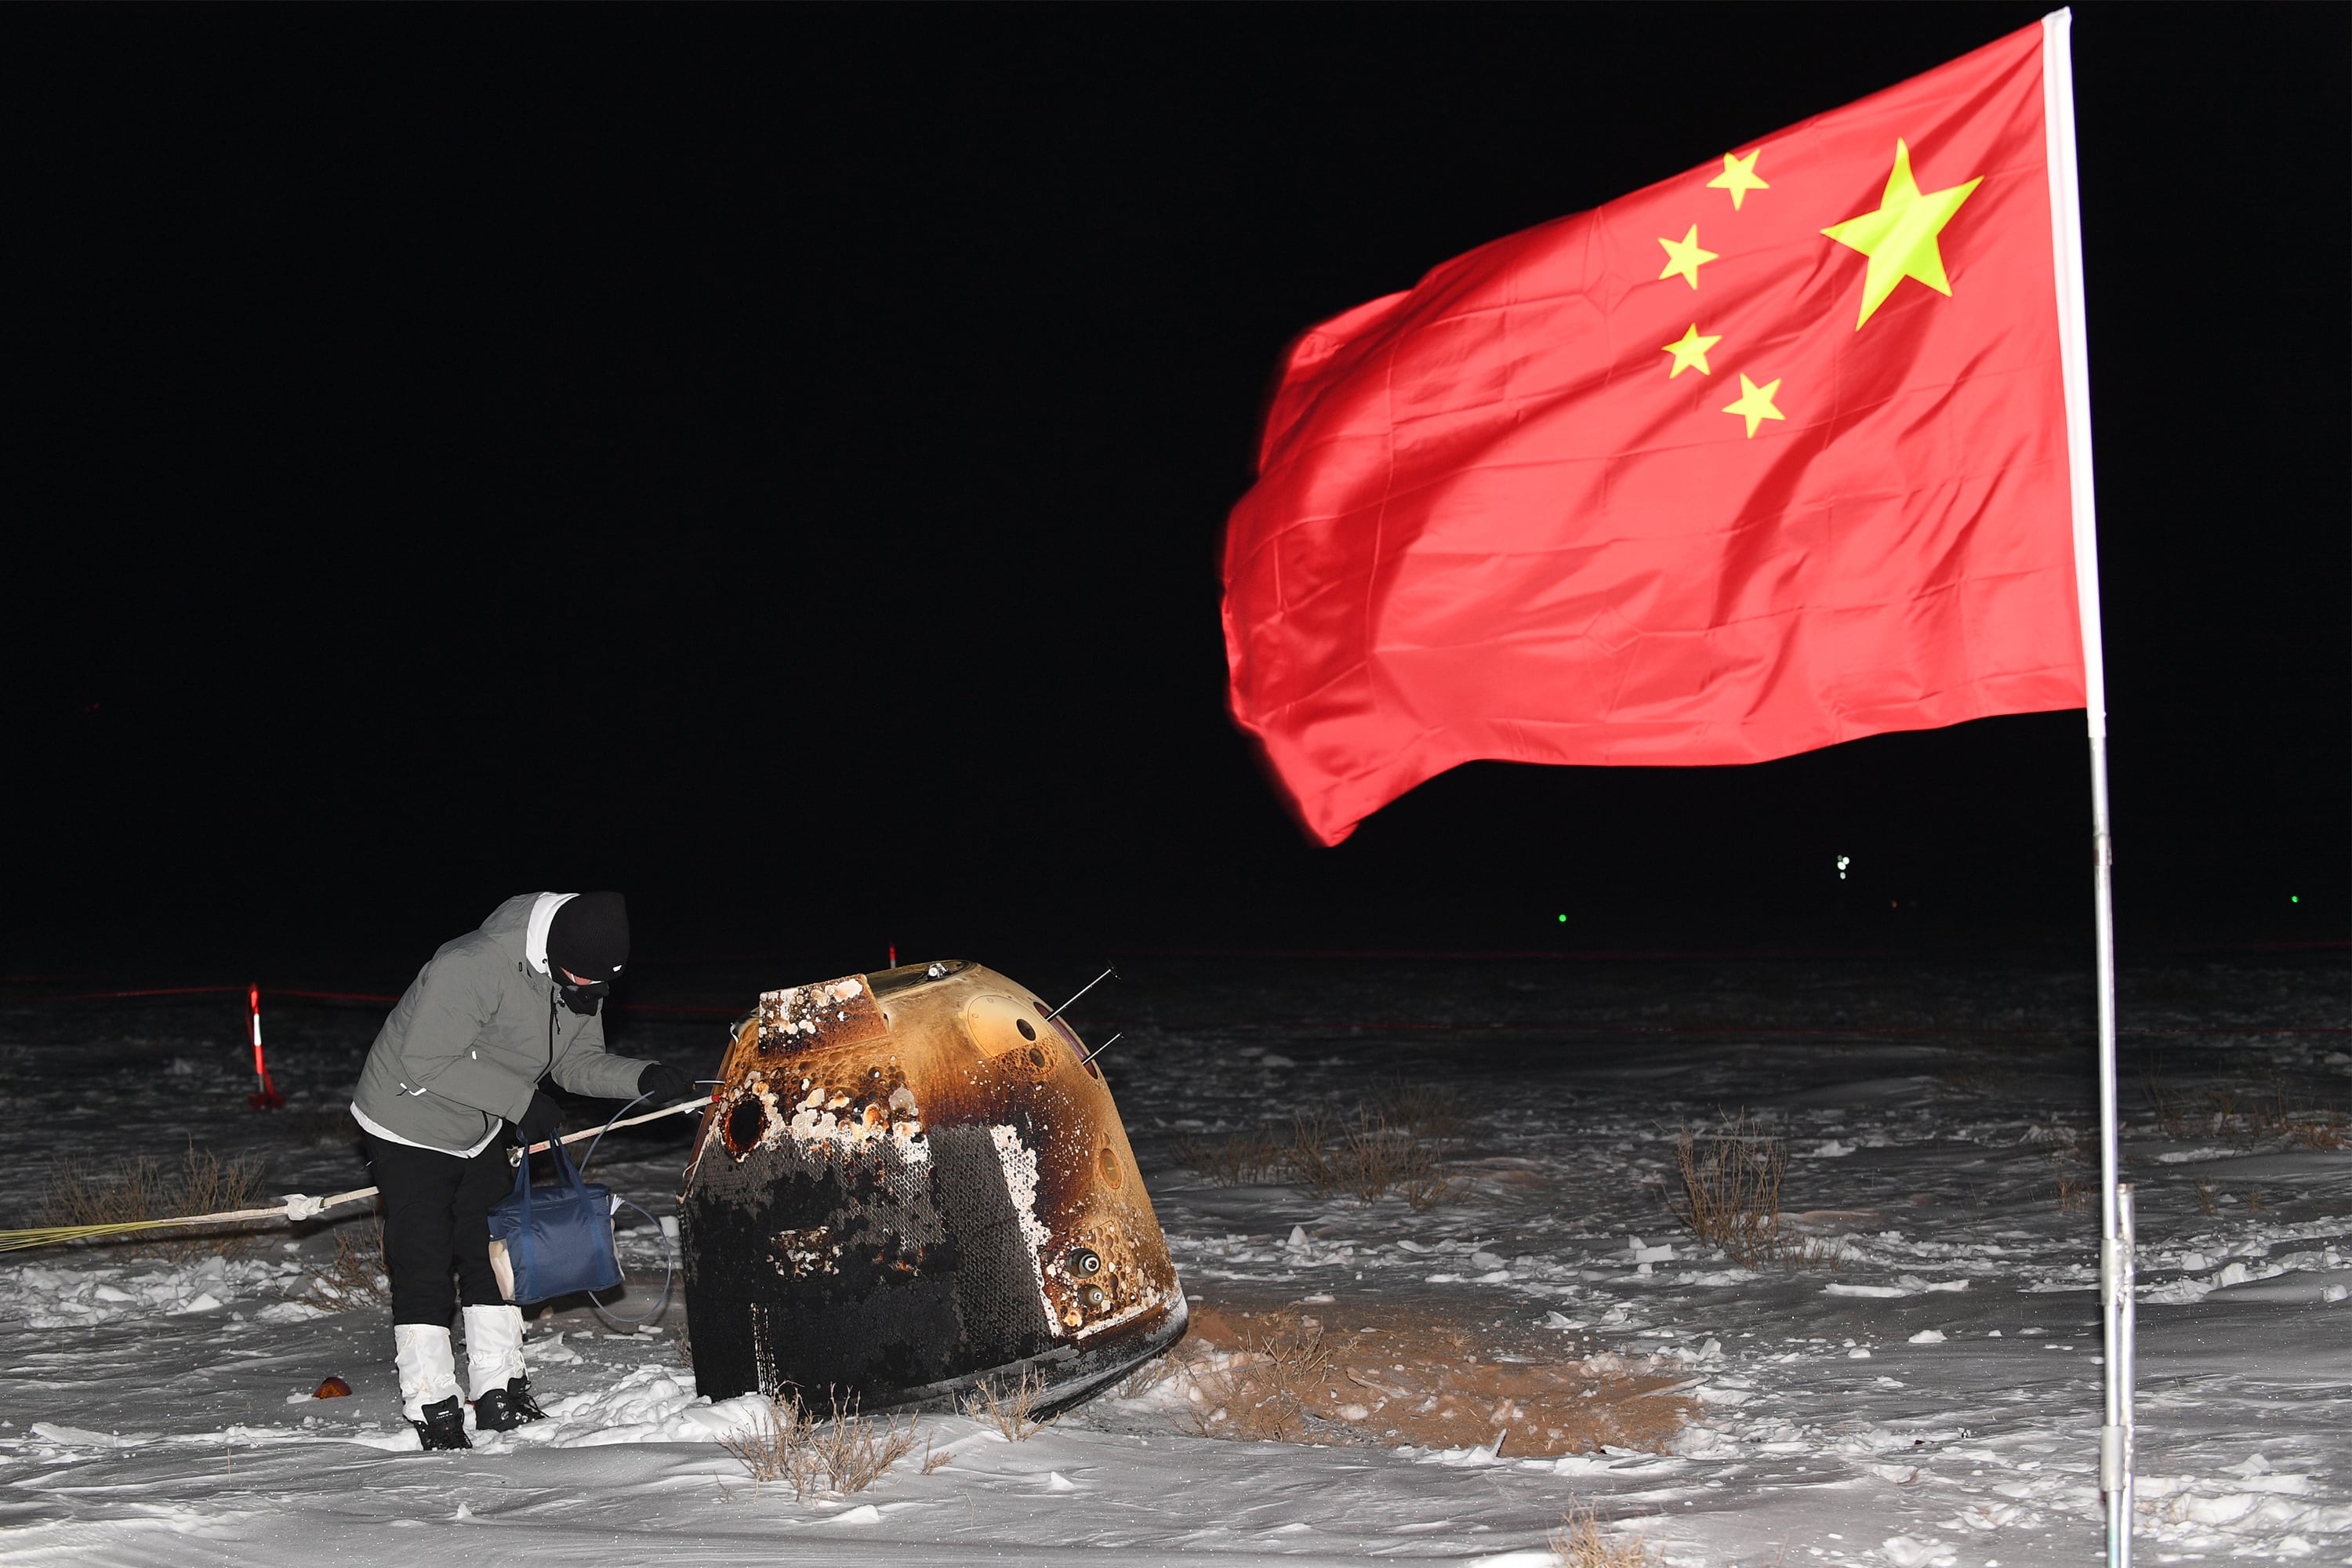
2042;12;2133;1568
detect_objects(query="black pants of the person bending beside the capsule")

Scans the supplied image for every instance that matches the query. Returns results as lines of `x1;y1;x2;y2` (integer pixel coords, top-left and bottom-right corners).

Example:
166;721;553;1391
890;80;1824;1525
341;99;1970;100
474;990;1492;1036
365;1133;515;1328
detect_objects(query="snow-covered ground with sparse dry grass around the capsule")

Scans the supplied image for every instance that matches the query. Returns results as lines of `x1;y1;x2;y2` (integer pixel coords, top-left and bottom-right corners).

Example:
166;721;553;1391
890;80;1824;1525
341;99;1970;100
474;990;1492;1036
0;949;2352;1568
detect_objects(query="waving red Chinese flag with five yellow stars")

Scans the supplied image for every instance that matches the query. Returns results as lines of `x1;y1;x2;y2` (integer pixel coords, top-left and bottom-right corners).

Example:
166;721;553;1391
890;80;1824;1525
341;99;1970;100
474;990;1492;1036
1225;26;2084;844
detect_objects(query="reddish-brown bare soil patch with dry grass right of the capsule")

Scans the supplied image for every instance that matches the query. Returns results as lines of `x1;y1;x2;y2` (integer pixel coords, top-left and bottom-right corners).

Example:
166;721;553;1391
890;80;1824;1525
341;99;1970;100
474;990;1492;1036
1174;1302;1689;1457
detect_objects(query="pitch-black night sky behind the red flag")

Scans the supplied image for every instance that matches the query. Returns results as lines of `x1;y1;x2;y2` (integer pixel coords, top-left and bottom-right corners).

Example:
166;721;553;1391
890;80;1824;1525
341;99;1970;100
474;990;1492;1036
0;5;2352;982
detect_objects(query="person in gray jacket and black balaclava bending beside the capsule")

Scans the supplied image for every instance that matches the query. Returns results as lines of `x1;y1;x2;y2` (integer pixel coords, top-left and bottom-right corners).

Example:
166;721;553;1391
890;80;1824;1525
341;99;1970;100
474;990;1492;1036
350;893;694;1448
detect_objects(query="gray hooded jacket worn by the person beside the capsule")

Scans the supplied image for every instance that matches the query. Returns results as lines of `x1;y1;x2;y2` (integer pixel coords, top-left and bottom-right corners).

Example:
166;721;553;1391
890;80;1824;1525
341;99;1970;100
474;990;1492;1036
350;893;644;1154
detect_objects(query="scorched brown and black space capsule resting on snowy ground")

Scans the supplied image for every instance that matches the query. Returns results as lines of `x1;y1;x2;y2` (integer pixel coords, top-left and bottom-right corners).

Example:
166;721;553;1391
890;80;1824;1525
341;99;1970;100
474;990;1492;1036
680;959;1185;1410
